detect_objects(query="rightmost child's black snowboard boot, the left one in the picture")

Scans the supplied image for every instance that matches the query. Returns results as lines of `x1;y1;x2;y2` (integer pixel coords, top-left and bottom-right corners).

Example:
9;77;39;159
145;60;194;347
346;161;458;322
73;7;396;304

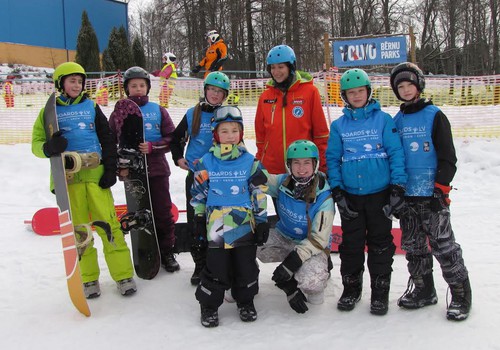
398;273;437;309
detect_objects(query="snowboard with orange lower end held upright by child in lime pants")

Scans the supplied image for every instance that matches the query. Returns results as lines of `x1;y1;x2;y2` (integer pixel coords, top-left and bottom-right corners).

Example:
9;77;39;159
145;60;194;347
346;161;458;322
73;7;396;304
43;93;90;316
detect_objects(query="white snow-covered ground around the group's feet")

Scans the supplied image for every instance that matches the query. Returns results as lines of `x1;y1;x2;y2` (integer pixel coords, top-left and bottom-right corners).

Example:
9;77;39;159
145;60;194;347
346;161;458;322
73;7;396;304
0;139;500;350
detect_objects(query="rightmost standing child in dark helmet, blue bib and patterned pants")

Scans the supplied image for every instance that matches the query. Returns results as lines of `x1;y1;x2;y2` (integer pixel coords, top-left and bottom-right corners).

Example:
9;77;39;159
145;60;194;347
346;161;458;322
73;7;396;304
391;62;472;321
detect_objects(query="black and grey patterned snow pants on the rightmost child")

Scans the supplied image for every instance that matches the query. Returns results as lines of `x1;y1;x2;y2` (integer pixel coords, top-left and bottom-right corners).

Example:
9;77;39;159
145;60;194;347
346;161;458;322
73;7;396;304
400;197;468;284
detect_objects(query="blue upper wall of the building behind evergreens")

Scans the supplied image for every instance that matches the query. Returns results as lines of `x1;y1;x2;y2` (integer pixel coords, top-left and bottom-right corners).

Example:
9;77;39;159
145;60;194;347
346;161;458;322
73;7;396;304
0;0;128;52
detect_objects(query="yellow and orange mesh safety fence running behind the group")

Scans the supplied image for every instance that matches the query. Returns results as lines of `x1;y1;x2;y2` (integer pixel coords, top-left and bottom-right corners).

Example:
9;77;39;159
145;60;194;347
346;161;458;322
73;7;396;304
0;72;500;144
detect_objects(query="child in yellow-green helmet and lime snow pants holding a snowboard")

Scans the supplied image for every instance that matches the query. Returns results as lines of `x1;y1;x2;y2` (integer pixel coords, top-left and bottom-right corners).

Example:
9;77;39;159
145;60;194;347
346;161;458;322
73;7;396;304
31;62;137;299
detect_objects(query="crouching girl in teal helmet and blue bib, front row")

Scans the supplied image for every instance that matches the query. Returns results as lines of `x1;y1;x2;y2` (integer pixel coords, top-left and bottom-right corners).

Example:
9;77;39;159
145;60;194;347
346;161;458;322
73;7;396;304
257;140;335;313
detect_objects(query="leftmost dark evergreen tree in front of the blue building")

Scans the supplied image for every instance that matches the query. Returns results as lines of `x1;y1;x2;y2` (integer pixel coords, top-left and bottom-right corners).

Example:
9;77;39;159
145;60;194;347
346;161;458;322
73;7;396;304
75;11;101;72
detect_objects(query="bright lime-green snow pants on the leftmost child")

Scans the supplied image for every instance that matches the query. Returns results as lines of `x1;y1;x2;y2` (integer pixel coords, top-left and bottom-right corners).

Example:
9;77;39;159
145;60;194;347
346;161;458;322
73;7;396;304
68;182;134;283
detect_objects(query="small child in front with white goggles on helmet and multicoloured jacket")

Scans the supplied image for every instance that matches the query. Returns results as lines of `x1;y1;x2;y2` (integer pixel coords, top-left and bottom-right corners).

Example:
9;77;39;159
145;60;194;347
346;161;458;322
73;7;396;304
191;106;269;327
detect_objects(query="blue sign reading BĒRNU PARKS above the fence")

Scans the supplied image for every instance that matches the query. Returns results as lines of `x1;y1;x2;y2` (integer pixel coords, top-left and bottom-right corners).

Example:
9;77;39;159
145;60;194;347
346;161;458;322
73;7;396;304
332;36;407;67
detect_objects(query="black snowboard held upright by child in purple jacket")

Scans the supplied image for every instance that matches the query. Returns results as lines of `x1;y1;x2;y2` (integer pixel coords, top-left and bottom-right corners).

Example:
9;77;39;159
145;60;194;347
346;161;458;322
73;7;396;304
113;99;161;279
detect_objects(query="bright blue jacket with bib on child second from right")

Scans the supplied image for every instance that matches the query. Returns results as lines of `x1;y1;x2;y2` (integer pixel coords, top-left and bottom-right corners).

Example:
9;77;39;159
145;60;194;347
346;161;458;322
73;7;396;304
326;99;407;195
